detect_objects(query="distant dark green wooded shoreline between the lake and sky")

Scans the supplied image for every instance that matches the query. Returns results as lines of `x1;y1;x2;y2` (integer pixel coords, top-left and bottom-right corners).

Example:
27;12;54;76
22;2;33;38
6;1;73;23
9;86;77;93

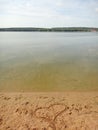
0;27;98;32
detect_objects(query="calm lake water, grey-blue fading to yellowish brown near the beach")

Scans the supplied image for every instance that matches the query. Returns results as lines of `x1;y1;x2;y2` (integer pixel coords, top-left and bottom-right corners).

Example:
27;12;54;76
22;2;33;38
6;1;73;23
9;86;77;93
0;32;98;91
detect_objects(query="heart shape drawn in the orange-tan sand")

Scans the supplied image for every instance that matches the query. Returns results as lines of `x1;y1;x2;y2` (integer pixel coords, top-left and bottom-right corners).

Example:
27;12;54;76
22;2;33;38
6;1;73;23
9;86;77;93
34;103;68;130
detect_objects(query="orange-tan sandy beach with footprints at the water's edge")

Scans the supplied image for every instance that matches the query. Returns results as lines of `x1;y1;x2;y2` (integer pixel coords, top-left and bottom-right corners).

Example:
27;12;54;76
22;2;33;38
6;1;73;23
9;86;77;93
0;92;98;130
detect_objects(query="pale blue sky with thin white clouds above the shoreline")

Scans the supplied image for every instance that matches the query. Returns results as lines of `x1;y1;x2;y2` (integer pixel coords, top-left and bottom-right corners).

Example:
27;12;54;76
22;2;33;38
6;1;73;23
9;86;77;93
0;0;98;28
